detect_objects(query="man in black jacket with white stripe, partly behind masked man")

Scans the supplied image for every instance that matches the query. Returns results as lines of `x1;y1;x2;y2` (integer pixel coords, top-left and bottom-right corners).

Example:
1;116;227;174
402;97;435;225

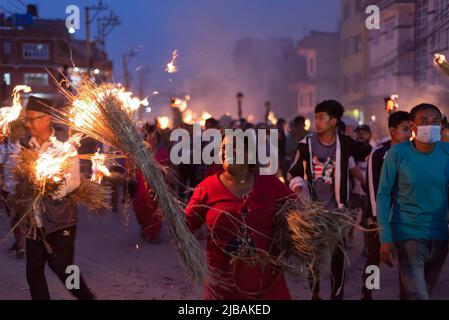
362;111;412;300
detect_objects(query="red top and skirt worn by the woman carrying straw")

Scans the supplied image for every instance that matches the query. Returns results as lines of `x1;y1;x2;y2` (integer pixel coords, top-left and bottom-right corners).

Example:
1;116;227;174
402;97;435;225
186;174;294;300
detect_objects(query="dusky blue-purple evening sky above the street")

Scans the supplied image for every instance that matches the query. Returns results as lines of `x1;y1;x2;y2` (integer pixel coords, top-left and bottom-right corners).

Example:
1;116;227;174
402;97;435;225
1;0;340;117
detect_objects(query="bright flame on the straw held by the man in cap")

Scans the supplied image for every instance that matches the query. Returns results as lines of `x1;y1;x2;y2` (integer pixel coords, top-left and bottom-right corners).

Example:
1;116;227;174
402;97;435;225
34;133;82;186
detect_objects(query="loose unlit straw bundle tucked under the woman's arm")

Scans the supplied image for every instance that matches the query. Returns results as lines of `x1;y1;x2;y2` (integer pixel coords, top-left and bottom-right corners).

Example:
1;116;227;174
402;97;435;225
274;200;356;273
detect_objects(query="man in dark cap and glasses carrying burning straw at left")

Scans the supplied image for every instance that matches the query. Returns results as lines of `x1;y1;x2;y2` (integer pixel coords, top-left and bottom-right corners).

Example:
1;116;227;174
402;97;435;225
18;96;94;300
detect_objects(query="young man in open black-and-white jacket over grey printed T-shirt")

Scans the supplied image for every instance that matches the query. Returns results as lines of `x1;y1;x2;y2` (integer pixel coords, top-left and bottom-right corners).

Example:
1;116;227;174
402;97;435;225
288;100;371;300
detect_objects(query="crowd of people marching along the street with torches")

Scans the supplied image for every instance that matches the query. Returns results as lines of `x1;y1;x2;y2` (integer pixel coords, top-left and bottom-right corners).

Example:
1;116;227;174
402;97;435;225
0;97;449;300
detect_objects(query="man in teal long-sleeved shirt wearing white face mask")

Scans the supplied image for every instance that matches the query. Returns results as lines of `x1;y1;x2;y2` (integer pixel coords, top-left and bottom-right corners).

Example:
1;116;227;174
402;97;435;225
377;104;449;299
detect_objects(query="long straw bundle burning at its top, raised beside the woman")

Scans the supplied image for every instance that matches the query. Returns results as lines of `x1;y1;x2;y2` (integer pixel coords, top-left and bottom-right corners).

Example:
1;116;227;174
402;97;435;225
54;79;206;281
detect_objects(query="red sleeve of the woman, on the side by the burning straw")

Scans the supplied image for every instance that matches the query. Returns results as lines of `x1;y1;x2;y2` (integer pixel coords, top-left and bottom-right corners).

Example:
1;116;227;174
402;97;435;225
185;184;207;232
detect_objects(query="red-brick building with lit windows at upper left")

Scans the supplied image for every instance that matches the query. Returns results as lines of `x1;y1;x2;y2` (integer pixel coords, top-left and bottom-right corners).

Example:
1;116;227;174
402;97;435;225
0;6;112;104
